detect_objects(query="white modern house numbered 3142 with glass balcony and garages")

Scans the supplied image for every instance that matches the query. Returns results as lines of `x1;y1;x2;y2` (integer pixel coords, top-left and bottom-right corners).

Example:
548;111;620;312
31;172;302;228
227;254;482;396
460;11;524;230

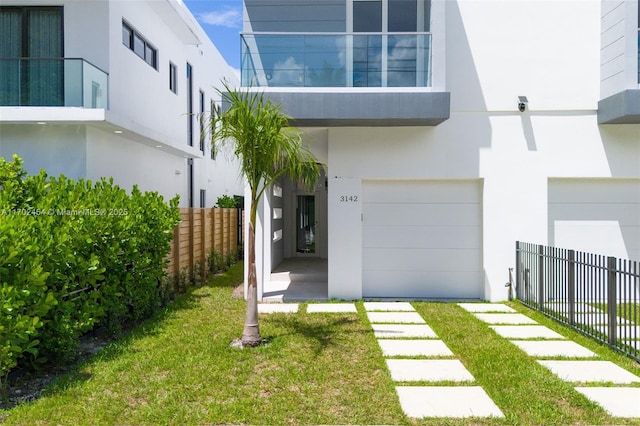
241;0;640;301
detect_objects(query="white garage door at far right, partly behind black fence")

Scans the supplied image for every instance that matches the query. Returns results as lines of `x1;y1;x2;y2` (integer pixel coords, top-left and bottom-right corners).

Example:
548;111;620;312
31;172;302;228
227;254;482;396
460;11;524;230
548;179;640;260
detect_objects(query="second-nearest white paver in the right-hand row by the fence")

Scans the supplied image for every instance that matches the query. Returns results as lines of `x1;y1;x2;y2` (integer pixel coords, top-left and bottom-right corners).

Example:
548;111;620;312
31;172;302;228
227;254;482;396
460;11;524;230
538;360;640;384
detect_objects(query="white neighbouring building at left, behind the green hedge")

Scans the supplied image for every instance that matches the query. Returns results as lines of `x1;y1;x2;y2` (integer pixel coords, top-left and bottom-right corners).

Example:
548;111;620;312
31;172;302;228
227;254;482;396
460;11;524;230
0;0;243;207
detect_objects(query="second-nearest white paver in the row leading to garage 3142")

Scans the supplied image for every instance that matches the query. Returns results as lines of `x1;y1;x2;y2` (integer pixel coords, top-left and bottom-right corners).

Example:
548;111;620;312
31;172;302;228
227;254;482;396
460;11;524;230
387;359;475;382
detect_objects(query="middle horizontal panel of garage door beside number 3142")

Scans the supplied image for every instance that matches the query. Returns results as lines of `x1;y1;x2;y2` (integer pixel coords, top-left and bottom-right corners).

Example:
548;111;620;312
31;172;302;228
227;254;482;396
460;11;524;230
363;226;482;249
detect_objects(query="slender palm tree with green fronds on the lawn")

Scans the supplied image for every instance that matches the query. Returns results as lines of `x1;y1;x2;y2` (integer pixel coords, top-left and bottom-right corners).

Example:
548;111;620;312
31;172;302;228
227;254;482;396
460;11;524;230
209;83;320;346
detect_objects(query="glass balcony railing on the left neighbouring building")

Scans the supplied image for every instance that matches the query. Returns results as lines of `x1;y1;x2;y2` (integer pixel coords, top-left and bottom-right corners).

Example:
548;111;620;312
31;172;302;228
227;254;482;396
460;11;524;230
0;58;109;108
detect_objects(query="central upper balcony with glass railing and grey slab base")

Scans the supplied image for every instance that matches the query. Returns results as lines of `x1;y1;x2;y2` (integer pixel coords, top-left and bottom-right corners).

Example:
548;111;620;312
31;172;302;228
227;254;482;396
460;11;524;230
236;33;450;127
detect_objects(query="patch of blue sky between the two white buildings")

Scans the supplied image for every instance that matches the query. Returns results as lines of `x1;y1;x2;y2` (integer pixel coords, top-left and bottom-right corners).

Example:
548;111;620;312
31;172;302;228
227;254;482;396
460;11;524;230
183;0;242;69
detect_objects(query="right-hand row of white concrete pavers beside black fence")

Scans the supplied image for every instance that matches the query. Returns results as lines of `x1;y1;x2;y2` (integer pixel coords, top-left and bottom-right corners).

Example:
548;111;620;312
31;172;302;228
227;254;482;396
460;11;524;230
458;303;640;418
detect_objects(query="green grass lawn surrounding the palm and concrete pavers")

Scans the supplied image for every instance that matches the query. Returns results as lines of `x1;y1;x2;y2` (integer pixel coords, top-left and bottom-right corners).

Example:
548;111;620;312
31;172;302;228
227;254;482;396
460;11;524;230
0;264;640;425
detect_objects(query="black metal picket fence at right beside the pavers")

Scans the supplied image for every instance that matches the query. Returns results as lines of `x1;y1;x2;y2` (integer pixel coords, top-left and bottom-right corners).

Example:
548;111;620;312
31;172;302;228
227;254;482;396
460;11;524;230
516;241;640;361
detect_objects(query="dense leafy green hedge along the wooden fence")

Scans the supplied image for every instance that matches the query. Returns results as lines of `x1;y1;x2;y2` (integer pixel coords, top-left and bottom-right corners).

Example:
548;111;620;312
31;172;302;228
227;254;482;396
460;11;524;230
0;157;180;377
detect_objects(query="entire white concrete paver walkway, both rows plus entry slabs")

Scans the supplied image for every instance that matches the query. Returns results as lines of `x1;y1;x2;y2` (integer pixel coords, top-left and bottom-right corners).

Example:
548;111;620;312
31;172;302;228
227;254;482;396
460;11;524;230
258;302;640;418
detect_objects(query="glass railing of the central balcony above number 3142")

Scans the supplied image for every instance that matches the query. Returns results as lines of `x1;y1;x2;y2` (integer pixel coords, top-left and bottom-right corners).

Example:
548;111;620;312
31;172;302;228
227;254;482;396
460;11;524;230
241;33;431;87
